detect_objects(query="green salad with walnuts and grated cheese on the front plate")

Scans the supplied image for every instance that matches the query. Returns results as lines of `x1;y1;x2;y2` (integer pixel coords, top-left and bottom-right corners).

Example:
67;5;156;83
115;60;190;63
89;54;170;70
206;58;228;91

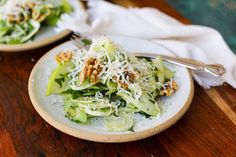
46;37;177;131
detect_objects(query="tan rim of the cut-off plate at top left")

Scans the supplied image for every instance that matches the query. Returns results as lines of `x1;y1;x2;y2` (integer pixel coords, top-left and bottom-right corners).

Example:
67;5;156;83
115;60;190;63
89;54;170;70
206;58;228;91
0;30;72;53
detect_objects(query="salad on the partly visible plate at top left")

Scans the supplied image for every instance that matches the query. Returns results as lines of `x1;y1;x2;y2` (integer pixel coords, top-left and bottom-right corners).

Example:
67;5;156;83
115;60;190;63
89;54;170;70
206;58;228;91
0;0;72;44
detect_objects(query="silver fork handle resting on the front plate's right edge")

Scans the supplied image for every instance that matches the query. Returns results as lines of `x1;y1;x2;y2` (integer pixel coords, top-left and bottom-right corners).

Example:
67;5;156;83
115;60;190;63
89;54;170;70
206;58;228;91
132;52;226;76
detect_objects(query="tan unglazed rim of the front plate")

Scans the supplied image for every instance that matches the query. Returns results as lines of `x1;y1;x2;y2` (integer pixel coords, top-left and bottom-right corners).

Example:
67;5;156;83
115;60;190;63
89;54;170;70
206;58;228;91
28;41;194;143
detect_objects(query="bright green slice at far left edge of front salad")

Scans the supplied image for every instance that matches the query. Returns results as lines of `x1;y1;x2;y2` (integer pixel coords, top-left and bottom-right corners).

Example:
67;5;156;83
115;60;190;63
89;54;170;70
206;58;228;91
46;61;74;96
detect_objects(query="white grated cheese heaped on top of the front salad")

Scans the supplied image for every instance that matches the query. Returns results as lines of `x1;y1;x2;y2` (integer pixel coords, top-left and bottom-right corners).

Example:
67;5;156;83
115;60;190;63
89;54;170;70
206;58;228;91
68;37;155;99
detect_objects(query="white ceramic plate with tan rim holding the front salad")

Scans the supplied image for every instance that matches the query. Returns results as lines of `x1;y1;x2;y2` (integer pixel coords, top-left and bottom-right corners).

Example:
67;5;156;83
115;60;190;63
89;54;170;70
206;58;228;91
28;36;194;142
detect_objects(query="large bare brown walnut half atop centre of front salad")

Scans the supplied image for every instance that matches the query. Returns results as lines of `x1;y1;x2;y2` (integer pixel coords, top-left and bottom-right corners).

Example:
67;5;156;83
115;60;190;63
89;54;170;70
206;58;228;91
79;57;102;84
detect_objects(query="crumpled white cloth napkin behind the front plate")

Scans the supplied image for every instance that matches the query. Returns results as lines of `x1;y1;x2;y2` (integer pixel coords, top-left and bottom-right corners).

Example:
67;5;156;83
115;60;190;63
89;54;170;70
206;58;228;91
55;1;236;88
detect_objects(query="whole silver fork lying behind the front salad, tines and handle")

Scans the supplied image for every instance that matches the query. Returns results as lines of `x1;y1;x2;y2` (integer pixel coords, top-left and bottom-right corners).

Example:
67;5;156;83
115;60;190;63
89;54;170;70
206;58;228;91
70;33;226;76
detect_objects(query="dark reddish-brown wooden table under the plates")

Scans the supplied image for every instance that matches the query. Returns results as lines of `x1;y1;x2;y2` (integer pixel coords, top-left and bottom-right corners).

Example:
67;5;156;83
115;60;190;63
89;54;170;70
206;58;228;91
0;0;236;157
